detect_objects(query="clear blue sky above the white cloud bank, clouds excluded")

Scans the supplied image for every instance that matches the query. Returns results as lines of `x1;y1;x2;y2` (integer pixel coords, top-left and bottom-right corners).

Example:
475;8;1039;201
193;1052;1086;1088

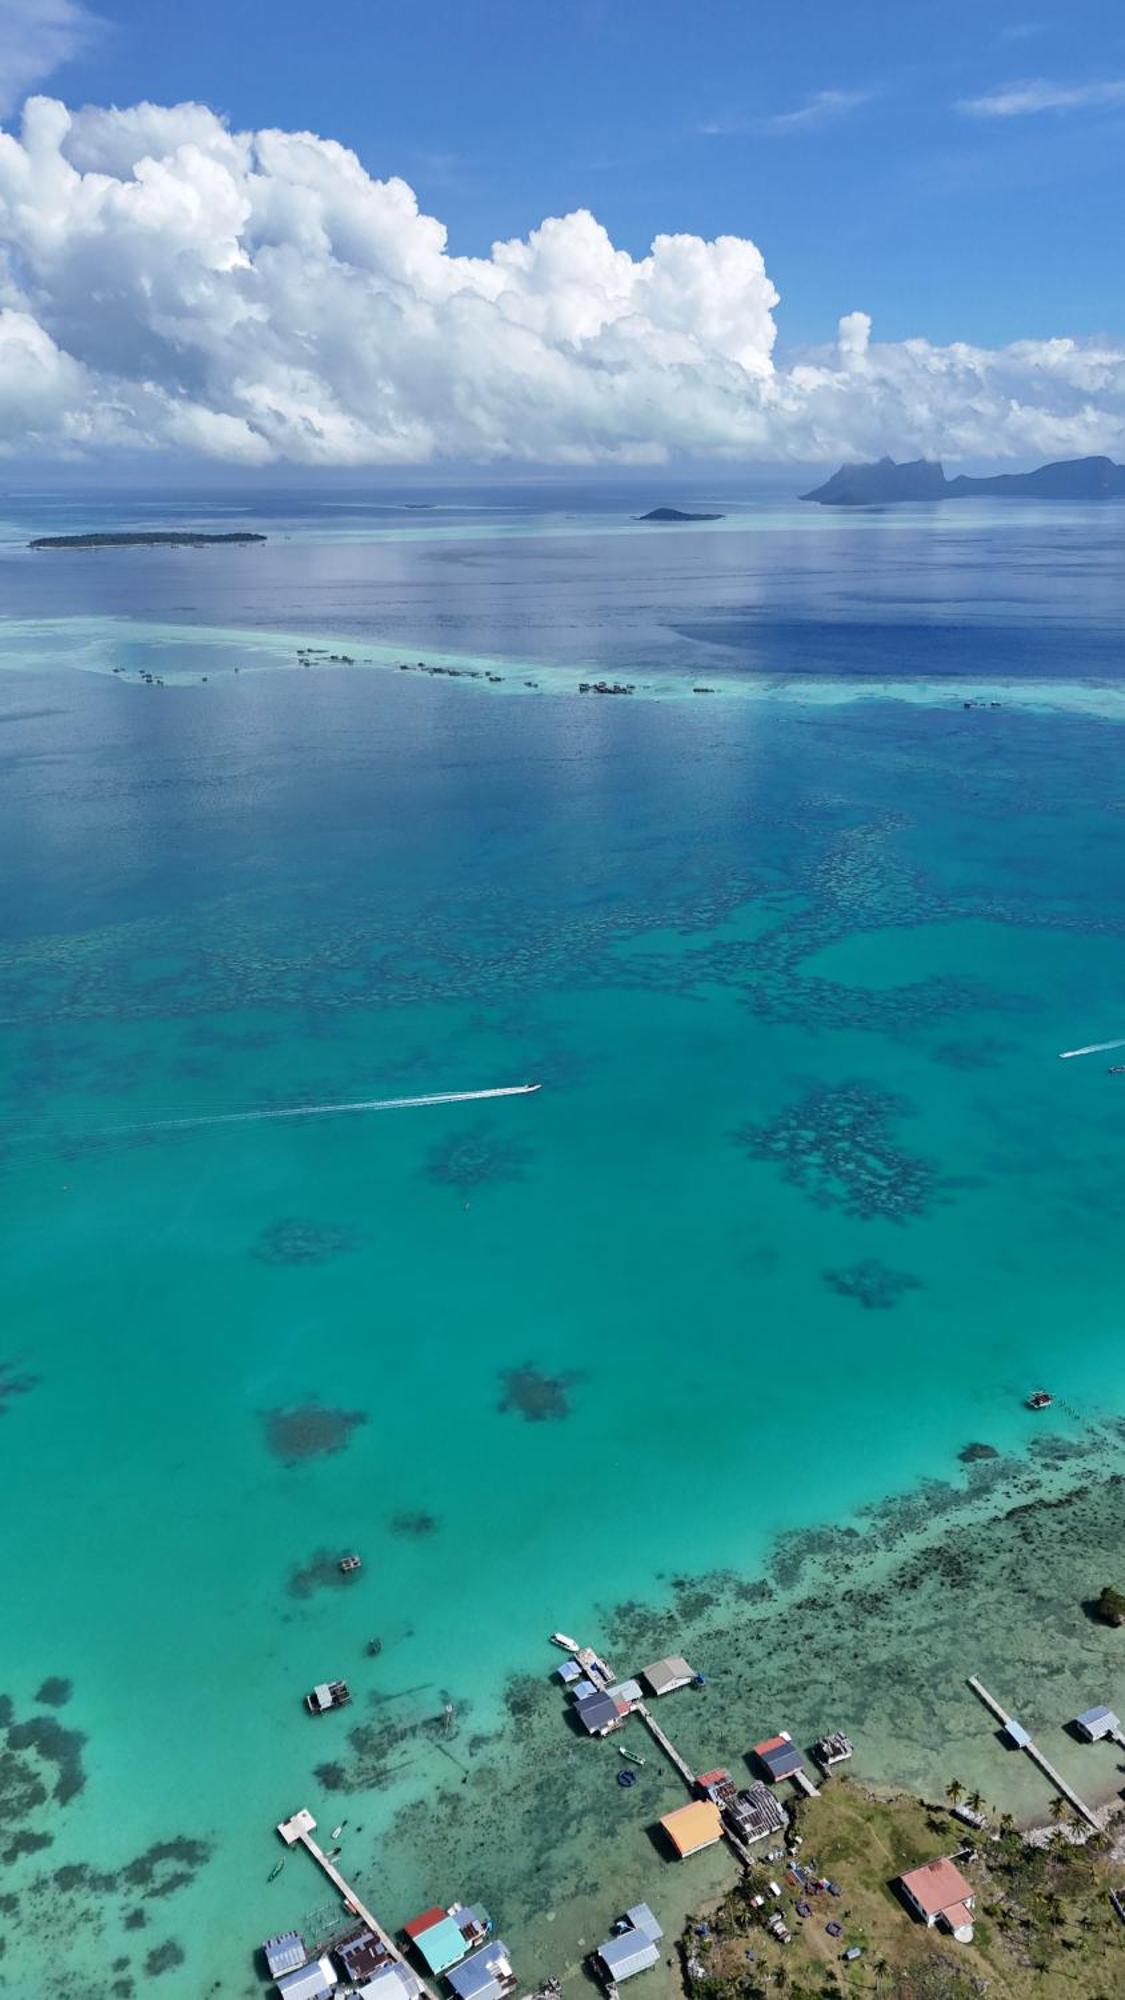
41;0;1125;344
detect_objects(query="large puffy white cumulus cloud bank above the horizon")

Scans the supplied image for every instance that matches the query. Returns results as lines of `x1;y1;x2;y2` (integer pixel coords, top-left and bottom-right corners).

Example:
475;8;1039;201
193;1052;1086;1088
0;98;1125;466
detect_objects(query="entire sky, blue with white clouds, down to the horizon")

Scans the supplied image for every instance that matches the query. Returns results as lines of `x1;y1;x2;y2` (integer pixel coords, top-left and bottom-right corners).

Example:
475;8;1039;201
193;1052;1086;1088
0;0;1125;464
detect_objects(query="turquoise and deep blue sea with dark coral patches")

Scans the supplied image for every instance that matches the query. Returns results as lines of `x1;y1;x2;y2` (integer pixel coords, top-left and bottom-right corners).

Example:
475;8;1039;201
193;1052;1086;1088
0;482;1125;2000
